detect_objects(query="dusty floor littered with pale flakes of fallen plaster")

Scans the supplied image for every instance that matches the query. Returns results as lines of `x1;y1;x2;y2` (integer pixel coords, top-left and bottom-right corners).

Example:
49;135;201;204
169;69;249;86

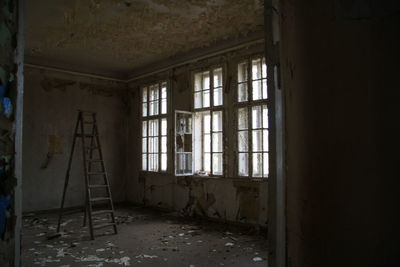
22;207;267;267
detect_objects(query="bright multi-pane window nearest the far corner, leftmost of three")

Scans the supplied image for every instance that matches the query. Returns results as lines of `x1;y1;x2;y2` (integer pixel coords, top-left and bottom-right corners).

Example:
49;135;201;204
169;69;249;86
142;82;168;172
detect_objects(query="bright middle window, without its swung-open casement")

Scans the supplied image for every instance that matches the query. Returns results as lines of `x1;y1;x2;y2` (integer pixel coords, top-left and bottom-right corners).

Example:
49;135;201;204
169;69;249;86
193;67;223;175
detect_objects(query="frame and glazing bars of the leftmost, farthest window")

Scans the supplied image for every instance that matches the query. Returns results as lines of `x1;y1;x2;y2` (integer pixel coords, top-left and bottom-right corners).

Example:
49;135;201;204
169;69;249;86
140;79;171;173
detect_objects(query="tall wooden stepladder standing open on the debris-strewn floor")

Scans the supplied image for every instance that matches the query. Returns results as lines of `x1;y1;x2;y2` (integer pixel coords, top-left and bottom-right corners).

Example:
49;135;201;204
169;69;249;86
57;110;117;240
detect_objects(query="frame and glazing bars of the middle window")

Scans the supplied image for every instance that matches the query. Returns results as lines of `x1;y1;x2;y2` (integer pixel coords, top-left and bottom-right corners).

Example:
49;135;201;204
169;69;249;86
190;64;227;177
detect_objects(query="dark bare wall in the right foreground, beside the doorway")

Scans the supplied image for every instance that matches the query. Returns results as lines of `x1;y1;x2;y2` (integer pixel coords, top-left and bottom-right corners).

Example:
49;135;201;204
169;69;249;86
281;0;400;267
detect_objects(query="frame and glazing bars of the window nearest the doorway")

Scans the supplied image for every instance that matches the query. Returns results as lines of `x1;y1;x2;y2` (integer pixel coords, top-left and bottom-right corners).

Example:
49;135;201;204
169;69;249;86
233;53;271;180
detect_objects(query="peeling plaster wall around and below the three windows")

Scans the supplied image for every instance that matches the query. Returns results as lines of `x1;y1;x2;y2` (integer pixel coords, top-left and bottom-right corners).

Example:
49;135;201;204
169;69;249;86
126;44;268;227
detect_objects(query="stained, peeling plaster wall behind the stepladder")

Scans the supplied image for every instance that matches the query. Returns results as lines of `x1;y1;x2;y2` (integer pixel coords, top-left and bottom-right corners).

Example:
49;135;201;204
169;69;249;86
22;67;128;212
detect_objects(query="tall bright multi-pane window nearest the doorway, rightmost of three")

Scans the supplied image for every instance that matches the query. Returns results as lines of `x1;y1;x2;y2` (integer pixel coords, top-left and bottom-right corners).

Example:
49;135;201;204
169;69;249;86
237;57;269;177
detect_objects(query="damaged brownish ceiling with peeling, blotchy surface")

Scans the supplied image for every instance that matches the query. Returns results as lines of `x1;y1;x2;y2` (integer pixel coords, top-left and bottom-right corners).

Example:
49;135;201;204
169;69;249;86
25;0;263;79
